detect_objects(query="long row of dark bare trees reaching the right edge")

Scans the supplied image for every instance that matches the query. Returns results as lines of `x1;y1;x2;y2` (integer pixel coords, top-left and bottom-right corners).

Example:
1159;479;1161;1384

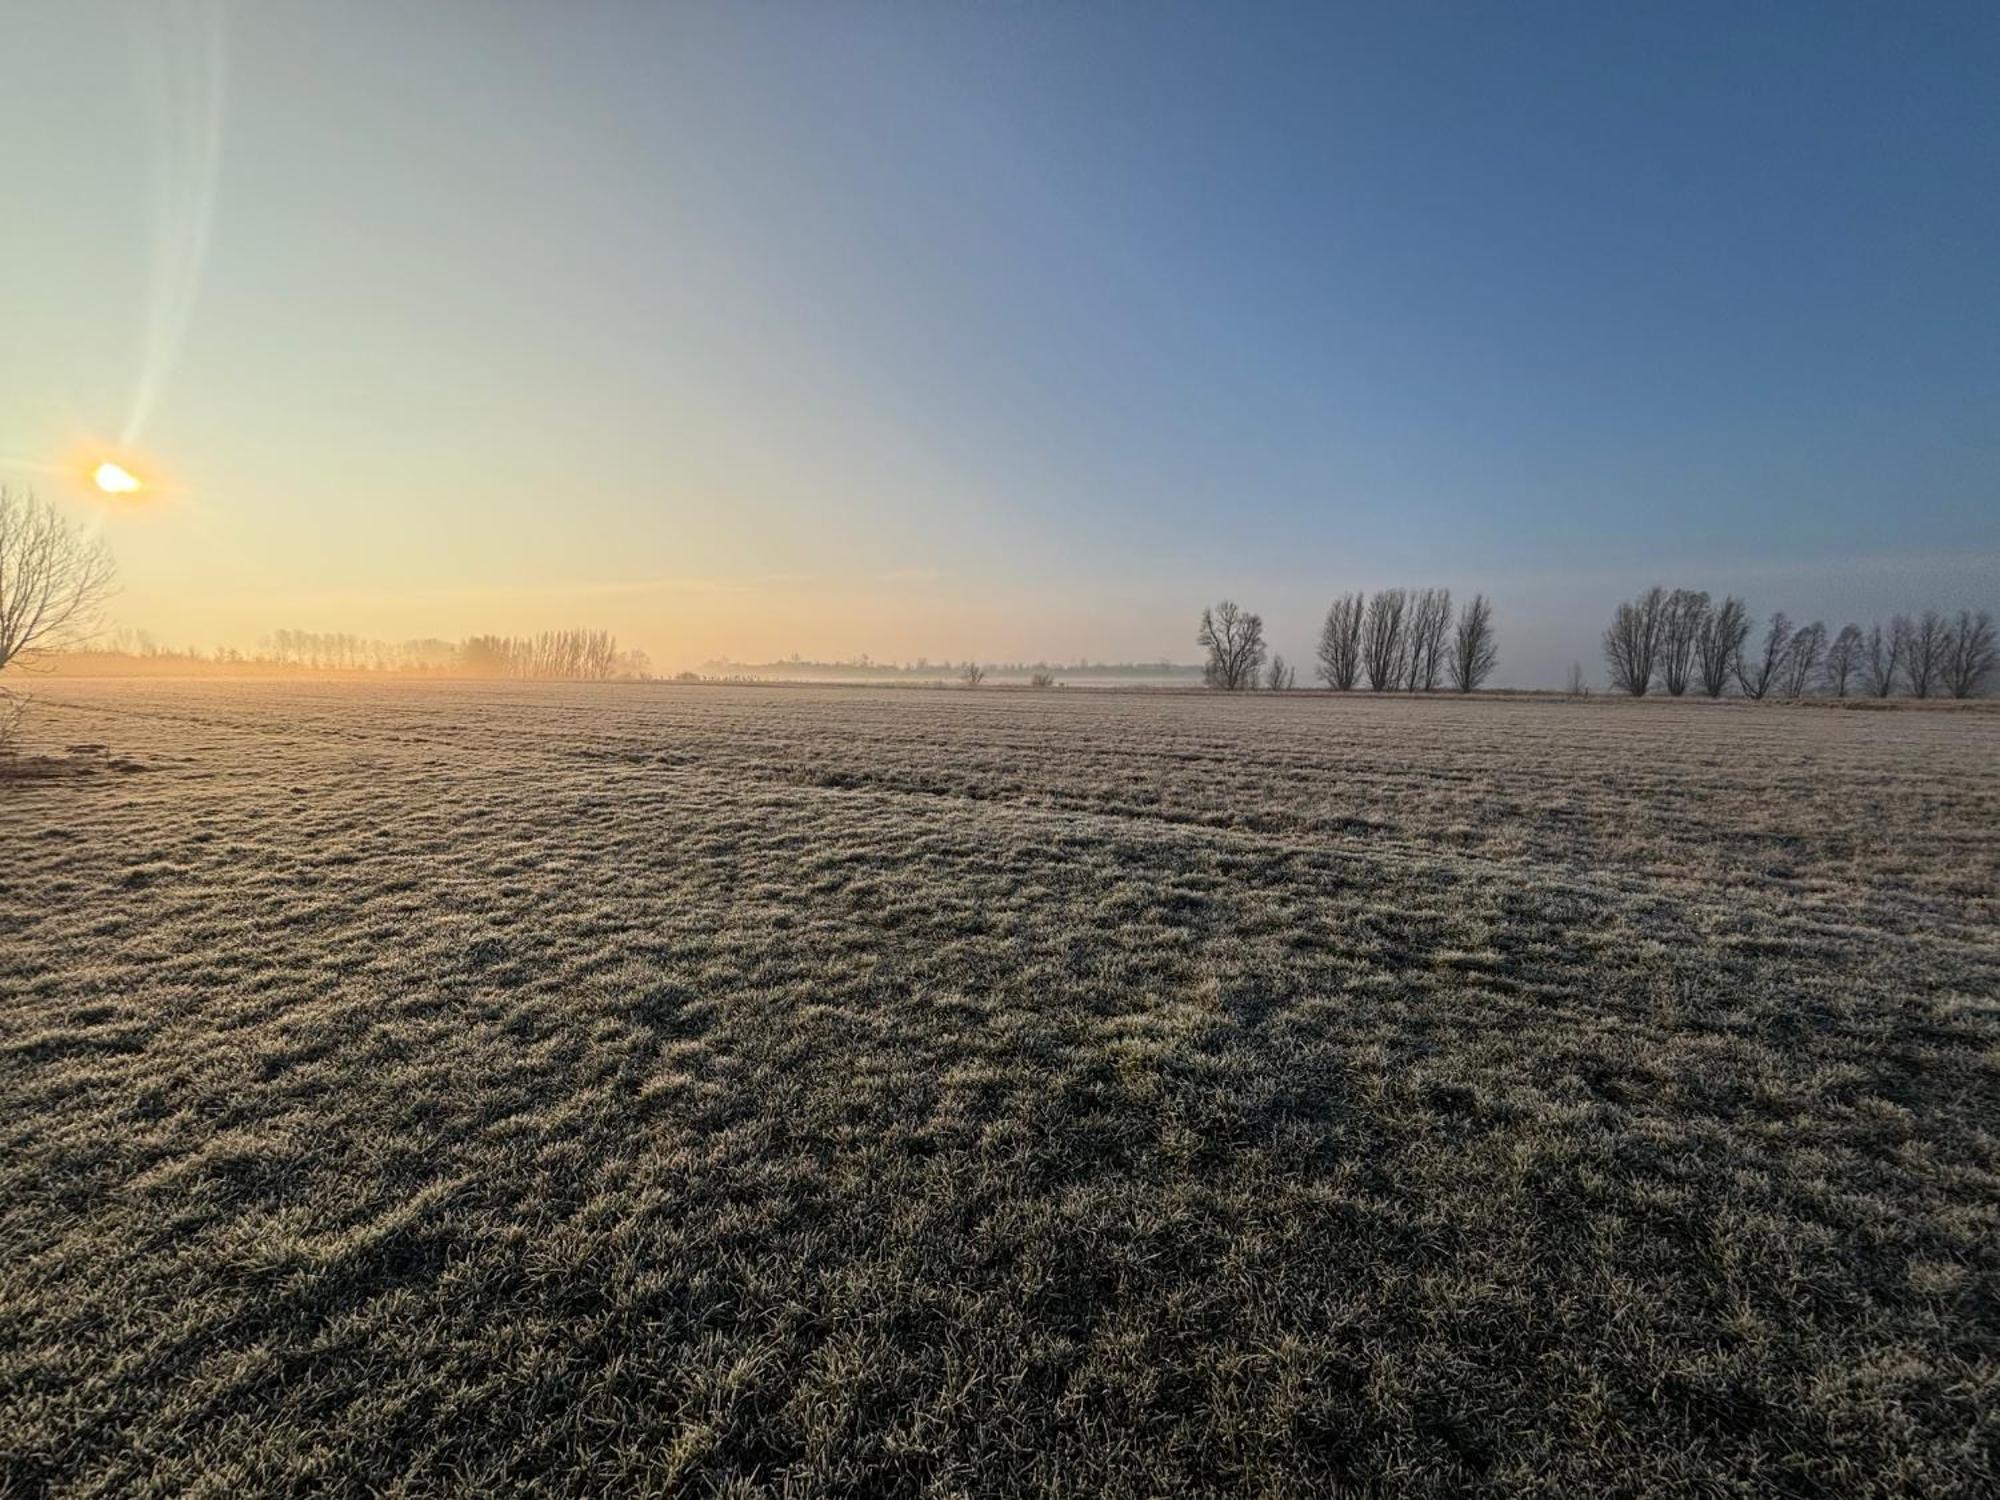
1604;584;1996;698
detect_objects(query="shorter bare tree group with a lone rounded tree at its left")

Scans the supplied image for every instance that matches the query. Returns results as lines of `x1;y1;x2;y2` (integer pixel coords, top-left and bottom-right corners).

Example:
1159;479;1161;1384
1194;588;1500;692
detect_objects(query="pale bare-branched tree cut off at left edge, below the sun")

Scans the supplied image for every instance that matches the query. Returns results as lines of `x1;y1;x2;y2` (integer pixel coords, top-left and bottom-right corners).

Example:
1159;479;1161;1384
0;486;112;738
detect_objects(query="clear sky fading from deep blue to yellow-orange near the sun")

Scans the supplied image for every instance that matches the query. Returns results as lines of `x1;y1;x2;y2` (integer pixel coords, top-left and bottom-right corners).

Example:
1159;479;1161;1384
0;0;2000;686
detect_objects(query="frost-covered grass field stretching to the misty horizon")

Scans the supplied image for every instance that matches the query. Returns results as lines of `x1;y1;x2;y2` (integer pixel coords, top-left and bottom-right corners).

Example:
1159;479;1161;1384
0;682;2000;1496
